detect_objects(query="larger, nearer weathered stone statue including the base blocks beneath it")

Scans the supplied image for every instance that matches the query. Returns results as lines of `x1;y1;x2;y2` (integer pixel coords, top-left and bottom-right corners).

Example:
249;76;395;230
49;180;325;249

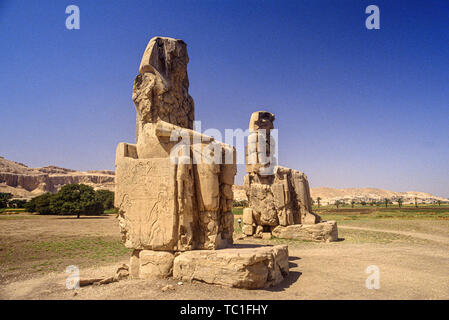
115;37;288;288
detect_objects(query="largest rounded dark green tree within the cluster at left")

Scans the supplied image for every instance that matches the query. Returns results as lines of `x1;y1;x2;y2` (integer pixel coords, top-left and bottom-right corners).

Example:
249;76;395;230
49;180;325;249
50;183;104;218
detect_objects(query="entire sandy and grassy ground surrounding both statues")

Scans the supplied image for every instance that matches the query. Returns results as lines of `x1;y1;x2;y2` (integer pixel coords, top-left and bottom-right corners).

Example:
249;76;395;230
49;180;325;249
0;206;449;300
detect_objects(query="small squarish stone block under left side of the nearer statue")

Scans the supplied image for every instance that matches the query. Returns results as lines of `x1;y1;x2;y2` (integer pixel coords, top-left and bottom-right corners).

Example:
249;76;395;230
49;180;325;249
139;250;175;279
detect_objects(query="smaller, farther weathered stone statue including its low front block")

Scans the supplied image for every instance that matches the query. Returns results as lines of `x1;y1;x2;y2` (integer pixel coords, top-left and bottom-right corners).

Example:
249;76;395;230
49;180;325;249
243;111;337;241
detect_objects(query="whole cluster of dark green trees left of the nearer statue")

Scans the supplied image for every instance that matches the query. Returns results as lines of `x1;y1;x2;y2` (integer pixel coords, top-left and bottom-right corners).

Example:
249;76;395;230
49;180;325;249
25;183;114;218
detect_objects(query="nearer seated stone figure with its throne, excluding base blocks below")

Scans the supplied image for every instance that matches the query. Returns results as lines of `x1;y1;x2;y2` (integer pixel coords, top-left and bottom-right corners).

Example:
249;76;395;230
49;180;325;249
115;37;236;252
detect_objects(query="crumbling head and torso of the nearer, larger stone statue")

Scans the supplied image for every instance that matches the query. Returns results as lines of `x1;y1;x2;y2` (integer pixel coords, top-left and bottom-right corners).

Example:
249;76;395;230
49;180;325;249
133;37;194;141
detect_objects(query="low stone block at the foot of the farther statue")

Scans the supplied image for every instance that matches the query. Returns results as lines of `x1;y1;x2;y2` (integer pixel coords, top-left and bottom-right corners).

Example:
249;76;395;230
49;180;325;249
272;221;338;242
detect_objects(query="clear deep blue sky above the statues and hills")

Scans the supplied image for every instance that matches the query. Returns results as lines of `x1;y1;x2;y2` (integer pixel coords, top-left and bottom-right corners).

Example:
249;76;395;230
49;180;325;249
0;0;449;197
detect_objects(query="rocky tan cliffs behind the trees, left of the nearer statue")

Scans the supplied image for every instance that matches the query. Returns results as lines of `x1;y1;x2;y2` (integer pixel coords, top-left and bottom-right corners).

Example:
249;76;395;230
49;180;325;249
0;156;114;198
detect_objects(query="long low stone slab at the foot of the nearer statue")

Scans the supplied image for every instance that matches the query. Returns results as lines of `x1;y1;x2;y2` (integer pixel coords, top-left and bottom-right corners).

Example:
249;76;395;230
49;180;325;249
173;245;289;289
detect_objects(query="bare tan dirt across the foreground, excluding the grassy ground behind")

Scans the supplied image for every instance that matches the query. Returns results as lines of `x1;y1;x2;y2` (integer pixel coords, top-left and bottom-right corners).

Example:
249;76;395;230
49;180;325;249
0;243;449;300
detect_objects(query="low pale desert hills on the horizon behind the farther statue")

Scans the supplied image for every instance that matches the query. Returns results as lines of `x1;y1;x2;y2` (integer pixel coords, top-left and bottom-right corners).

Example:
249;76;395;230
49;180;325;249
233;185;449;205
